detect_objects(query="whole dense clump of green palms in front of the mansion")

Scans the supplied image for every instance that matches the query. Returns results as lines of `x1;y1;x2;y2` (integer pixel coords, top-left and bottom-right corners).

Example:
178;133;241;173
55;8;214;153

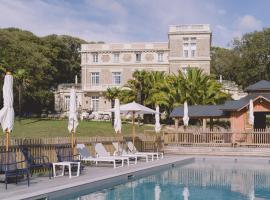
120;68;229;119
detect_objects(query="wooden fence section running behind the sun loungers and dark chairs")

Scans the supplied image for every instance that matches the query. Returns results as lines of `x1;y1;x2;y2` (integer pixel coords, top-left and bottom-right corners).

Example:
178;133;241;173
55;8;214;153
0;135;161;162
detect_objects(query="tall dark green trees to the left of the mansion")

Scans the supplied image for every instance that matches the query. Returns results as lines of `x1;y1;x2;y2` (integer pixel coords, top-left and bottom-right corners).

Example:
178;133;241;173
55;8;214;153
0;28;85;113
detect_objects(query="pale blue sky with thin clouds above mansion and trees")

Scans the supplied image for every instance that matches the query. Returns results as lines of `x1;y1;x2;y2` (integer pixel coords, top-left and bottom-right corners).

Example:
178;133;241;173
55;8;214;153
0;0;270;47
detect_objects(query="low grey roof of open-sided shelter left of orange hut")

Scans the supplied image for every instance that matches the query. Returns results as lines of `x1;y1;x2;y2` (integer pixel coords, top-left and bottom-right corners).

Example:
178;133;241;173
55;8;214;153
170;105;225;118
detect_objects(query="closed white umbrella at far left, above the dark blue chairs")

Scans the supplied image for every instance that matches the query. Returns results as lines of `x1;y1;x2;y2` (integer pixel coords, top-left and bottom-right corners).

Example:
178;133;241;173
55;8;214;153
0;72;14;151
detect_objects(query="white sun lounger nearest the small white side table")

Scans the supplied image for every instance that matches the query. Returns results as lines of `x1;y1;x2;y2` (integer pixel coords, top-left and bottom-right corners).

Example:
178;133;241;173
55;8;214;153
77;144;124;168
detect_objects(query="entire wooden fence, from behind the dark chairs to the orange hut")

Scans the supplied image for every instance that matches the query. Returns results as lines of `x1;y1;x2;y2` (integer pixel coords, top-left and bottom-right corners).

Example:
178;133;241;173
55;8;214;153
0;128;270;166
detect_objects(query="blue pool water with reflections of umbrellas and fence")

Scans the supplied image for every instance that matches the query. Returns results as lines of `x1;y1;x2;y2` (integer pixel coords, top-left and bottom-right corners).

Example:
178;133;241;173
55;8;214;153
60;159;270;200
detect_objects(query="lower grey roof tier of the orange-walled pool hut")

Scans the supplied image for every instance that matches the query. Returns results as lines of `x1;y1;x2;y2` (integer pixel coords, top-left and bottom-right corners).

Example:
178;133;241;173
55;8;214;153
220;93;270;111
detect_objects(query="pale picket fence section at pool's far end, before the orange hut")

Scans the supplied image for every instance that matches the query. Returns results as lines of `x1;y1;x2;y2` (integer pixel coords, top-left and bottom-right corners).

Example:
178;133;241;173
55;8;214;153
163;128;270;147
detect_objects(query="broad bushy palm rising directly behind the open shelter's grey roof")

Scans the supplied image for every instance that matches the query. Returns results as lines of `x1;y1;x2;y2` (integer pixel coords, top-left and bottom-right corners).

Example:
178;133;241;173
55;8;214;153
163;68;228;116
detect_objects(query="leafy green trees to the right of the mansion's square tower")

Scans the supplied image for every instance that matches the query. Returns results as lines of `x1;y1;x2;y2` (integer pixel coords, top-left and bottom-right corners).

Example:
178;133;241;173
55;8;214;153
211;28;270;88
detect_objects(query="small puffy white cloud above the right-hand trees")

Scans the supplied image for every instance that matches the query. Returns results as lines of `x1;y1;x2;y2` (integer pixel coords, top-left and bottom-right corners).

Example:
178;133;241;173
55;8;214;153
236;15;262;31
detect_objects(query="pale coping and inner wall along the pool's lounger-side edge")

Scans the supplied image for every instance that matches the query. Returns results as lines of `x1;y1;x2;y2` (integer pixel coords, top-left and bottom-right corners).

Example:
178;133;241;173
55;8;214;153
7;156;195;200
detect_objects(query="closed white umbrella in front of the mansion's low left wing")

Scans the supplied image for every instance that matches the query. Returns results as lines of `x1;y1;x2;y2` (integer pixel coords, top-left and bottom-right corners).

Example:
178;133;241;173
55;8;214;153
68;88;79;153
